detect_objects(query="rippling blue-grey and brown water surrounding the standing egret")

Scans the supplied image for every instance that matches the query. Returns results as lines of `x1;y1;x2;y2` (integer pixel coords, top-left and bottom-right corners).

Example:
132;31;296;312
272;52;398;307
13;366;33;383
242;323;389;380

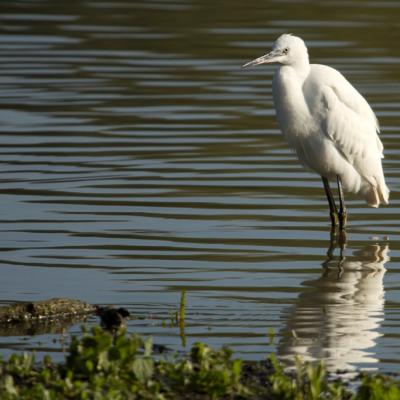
0;0;400;371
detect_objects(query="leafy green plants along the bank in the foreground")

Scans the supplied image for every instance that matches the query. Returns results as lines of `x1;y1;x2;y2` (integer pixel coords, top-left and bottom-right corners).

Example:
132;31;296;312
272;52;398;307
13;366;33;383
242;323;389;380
0;327;400;400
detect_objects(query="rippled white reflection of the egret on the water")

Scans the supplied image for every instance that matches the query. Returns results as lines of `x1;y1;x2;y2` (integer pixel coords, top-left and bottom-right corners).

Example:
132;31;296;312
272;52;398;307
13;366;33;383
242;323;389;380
278;236;389;373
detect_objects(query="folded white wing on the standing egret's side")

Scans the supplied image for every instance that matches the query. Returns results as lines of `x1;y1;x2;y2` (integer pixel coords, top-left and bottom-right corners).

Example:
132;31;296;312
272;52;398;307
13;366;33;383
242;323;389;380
310;65;383;186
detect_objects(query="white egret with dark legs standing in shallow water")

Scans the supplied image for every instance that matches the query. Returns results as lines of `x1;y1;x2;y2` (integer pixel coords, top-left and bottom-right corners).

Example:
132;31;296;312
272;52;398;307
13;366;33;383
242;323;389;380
243;34;389;229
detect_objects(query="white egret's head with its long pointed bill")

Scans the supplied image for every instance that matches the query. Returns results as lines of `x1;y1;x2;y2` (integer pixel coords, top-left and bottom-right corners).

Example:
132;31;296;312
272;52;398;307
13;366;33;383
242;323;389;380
243;33;308;67
